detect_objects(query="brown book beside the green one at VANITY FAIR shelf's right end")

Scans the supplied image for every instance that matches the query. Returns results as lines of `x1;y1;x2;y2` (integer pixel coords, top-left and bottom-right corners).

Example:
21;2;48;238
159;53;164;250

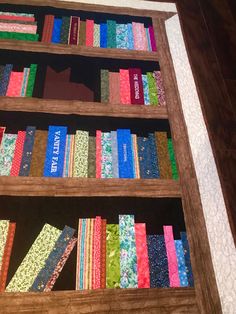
155;132;172;179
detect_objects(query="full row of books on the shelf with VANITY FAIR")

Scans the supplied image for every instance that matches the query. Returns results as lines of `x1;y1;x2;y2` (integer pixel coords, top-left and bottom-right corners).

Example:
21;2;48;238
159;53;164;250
0;126;178;179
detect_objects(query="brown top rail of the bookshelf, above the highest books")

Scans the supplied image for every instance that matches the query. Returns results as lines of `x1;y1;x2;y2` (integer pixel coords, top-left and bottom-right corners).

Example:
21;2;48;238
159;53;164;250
0;0;175;20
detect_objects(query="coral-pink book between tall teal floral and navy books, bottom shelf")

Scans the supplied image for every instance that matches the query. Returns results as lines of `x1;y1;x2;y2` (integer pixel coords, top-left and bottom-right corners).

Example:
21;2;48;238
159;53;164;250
135;223;150;288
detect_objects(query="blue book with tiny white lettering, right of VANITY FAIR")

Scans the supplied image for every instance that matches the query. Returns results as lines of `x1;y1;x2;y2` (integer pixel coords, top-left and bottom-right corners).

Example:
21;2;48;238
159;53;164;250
117;129;134;178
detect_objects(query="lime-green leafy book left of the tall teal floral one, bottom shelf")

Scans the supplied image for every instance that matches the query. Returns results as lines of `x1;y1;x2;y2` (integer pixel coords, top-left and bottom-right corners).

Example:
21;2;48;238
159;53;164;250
106;224;120;288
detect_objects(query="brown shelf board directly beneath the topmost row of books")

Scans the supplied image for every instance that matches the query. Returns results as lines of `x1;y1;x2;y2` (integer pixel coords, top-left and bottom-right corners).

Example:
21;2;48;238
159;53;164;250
0;39;159;62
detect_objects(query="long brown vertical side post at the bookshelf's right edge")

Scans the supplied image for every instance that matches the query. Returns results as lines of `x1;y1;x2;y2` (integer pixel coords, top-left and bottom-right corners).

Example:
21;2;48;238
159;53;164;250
153;19;221;314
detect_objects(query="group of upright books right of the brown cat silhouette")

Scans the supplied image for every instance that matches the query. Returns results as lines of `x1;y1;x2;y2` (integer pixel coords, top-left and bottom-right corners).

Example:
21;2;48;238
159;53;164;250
100;68;166;106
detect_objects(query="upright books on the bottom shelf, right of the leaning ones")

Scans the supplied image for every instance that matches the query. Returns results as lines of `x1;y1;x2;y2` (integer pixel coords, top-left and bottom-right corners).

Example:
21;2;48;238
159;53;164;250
76;215;193;290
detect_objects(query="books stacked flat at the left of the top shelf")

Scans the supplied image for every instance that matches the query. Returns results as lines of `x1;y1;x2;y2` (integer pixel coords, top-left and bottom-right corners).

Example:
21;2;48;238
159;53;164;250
0;12;39;41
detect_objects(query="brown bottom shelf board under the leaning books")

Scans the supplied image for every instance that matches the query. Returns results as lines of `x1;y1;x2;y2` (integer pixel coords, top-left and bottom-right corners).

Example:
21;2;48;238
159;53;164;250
0;288;198;314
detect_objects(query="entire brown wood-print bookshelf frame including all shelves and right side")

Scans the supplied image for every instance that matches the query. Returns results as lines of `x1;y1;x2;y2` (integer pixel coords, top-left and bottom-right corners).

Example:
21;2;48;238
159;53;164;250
0;0;221;314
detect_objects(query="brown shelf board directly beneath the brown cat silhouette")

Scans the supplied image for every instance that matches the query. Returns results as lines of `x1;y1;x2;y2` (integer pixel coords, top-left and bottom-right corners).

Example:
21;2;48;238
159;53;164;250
0;97;168;119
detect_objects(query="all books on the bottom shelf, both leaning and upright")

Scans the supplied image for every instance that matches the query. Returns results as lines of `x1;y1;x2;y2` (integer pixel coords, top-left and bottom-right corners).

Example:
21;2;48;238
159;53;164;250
0;215;194;292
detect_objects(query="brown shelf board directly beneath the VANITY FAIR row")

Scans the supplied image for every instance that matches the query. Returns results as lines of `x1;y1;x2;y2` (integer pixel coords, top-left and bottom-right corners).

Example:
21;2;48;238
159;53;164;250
0;177;181;198
